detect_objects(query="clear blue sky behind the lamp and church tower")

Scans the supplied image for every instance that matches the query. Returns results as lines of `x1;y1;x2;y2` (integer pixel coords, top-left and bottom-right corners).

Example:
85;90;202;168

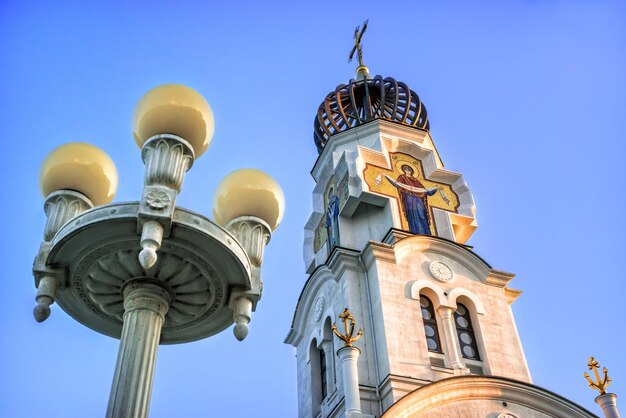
0;0;626;418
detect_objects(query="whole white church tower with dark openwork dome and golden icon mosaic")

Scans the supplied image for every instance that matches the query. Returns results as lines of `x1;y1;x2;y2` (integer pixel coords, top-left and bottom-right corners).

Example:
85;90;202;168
285;22;593;418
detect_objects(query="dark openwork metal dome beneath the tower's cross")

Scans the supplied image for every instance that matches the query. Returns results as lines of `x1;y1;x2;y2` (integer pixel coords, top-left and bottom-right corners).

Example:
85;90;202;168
313;75;430;153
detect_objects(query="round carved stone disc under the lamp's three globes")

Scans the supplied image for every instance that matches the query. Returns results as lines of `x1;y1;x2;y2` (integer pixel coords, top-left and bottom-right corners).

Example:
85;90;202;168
47;203;251;344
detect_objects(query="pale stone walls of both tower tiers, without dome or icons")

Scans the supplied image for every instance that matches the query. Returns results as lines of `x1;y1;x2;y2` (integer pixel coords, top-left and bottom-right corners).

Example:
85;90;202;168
285;121;530;417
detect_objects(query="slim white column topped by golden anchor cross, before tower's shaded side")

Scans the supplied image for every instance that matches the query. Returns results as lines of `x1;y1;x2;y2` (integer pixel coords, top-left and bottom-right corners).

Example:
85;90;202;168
333;308;363;416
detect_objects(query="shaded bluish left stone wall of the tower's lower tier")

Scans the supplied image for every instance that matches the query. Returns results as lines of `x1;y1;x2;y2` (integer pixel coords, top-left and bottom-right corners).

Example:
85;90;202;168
286;249;380;417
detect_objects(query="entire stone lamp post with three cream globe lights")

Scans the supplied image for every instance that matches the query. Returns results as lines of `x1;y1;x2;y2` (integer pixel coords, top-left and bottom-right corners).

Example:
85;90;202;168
33;84;284;417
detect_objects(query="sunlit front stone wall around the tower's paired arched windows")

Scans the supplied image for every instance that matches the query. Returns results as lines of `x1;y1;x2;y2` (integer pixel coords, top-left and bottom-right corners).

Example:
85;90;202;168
364;236;531;407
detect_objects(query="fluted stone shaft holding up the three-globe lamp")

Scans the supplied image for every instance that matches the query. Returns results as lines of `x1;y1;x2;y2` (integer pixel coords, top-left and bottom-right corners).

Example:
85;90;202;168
106;279;171;418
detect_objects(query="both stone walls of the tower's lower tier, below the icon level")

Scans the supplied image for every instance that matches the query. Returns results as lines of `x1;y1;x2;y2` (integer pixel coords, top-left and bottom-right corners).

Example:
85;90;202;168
288;236;531;416
